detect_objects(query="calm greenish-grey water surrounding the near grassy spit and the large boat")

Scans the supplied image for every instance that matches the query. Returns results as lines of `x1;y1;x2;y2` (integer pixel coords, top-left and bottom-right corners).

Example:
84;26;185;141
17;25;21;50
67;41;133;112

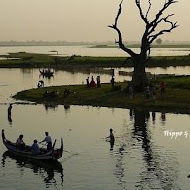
0;45;190;190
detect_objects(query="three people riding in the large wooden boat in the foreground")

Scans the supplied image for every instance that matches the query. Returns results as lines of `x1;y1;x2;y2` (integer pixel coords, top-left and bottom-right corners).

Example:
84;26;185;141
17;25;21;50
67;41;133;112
16;132;52;155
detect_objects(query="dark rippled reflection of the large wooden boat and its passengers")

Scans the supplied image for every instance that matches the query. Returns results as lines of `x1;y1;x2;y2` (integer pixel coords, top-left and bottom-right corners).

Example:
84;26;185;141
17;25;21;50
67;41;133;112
1;151;64;188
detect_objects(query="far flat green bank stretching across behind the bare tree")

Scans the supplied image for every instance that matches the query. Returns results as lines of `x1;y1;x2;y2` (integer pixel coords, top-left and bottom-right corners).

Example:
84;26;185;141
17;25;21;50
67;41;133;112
0;52;190;68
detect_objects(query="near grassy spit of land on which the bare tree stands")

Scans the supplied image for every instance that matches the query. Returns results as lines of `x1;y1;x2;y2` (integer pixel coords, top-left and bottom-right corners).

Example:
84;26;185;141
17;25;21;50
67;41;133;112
14;77;190;113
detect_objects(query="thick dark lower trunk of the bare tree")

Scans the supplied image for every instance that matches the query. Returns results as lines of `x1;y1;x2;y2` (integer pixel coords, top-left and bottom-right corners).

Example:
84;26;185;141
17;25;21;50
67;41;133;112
131;62;148;92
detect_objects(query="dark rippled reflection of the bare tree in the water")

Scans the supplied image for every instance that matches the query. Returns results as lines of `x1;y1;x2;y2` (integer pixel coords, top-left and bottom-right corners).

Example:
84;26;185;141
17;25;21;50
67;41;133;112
132;110;180;189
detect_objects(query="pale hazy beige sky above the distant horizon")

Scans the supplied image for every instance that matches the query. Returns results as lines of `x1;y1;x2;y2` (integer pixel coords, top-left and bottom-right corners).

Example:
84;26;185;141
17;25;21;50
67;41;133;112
0;0;190;41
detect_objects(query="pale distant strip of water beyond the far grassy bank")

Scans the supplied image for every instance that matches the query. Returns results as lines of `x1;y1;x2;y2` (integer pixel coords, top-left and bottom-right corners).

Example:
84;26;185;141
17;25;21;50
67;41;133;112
0;46;190;57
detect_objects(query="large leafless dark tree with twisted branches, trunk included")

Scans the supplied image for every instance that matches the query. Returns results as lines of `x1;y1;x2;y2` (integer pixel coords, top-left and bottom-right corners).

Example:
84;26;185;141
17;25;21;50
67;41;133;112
108;0;178;91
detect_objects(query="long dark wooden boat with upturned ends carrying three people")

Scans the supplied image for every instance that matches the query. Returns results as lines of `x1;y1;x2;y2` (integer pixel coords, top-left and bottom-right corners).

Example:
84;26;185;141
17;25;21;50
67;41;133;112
2;129;63;160
